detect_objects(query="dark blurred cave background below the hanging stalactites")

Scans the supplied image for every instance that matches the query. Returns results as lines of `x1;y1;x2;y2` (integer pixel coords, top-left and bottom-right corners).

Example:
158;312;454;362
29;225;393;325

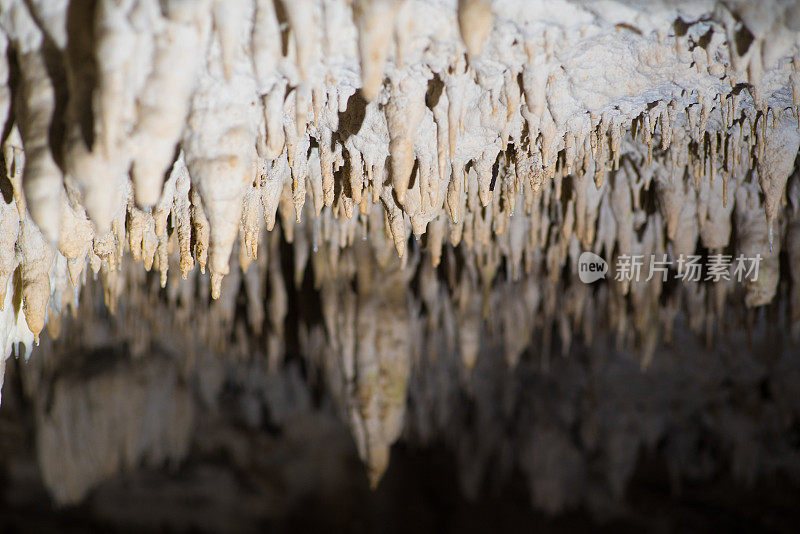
0;238;800;533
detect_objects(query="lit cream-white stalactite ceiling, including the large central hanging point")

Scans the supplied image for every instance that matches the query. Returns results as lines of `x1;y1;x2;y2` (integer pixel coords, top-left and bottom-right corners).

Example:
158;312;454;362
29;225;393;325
0;0;800;494
